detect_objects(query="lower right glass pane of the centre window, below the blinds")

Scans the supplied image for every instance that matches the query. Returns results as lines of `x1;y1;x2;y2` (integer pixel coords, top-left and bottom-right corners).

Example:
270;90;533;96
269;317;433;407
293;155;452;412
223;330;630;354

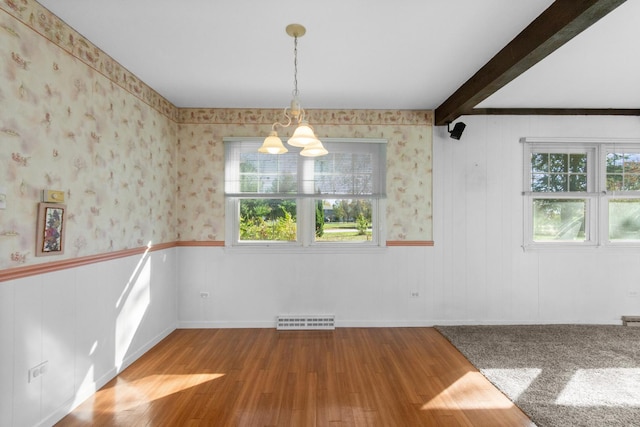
315;199;372;242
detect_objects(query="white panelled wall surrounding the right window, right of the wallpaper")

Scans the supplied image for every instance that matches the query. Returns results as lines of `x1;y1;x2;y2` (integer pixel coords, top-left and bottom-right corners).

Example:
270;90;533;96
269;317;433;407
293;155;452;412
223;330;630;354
426;116;640;324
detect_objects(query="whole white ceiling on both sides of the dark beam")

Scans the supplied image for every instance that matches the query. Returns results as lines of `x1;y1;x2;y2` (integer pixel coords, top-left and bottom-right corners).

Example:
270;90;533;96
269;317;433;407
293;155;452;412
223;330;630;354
39;0;640;109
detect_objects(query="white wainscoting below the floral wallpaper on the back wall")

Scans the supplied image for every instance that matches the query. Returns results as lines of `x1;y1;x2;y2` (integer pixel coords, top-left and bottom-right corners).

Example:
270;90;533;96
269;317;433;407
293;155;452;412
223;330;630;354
178;247;434;328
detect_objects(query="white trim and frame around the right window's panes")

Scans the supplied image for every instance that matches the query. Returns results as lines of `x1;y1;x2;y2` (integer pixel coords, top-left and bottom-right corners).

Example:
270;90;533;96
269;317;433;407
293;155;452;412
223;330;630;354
520;137;640;251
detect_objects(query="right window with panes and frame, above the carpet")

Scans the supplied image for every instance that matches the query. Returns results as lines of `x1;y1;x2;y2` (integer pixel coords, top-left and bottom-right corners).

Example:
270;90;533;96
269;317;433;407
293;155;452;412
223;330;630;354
523;139;640;247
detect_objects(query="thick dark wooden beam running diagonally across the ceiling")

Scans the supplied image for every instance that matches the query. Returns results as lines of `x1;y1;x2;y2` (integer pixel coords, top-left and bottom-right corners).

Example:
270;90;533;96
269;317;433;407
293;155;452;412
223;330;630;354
435;0;625;126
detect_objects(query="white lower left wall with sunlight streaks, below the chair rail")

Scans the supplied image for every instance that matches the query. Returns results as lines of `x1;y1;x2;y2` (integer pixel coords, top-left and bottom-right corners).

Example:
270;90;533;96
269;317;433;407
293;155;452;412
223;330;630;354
0;248;177;426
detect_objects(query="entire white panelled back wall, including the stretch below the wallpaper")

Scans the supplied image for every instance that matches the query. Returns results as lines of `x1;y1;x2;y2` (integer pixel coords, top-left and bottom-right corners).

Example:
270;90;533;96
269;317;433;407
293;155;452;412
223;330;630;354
178;116;640;327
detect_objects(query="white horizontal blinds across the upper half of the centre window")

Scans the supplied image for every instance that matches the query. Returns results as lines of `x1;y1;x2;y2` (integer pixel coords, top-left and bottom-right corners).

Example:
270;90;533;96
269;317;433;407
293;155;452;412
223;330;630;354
225;140;386;198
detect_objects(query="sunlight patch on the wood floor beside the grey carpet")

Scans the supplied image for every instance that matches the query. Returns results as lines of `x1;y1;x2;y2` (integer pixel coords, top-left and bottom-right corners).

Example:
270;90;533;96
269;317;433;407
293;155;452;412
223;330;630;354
421;372;513;411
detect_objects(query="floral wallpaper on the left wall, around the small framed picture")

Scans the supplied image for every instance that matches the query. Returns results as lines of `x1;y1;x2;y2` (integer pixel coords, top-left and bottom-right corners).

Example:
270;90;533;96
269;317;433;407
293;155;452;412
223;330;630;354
0;2;177;268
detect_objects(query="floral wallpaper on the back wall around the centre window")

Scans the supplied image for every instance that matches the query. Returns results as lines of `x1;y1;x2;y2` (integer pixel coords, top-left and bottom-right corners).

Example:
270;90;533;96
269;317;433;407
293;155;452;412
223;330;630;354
178;109;433;241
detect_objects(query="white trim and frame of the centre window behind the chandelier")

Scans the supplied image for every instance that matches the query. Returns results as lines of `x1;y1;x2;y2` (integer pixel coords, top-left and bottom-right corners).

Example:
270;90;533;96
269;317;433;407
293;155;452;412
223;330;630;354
223;137;388;253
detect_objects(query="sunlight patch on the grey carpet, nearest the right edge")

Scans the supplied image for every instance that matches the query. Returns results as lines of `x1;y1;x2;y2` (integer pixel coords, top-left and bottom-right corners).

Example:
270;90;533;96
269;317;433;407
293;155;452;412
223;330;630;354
556;368;640;407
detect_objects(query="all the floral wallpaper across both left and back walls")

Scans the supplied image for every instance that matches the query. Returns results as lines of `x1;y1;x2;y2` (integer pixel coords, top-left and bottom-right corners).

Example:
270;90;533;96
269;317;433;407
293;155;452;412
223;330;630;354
0;0;433;269
